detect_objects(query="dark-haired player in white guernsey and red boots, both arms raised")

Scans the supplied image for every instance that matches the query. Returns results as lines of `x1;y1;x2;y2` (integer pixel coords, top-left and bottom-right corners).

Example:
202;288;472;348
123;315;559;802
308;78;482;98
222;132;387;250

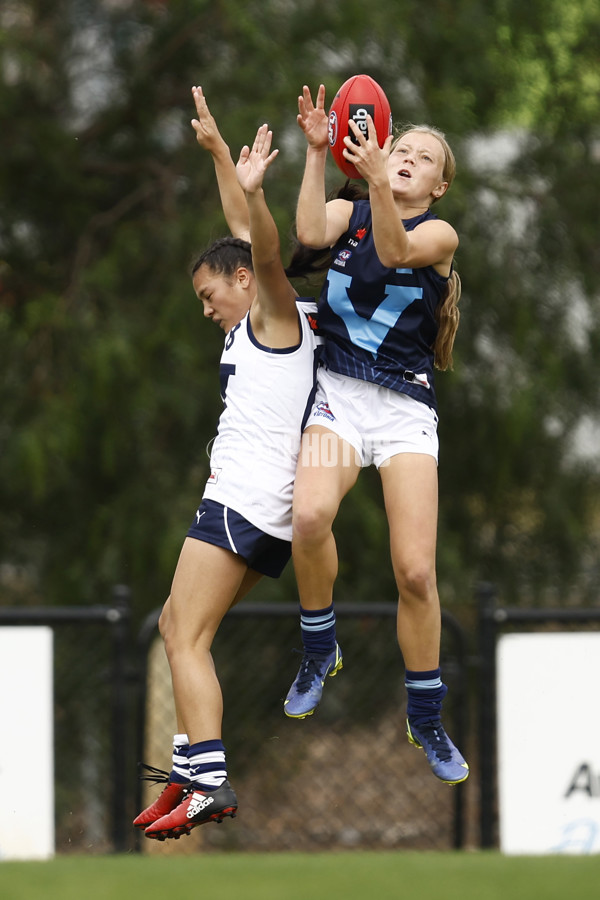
134;98;318;840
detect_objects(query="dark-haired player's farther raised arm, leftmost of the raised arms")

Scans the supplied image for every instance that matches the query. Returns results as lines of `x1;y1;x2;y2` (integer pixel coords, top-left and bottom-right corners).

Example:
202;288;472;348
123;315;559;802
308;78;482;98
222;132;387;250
192;87;250;241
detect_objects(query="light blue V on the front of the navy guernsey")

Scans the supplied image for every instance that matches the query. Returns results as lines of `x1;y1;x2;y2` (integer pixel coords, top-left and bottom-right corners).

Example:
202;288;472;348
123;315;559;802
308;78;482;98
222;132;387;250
327;270;423;357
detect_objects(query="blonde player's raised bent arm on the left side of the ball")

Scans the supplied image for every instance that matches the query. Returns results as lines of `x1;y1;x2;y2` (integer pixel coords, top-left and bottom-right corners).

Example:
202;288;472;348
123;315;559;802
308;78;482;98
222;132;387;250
296;85;352;250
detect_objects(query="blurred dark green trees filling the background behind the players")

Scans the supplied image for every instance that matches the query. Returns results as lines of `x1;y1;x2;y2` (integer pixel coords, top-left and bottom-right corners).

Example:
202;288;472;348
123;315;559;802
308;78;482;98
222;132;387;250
0;0;600;615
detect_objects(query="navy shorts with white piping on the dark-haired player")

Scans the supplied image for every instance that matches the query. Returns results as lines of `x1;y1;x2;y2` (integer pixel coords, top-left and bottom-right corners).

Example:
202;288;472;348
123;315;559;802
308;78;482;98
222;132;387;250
187;500;292;578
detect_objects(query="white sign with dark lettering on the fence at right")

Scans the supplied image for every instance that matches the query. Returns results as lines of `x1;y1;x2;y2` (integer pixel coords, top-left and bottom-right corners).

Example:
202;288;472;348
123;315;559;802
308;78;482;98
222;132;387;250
497;632;600;854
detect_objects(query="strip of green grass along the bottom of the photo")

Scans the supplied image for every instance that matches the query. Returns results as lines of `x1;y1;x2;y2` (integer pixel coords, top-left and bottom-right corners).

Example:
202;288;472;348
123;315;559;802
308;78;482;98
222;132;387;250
0;851;600;900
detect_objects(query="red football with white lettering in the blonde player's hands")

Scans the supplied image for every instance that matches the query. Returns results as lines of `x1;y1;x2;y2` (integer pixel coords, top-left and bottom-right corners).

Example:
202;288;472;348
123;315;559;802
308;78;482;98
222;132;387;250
329;75;392;178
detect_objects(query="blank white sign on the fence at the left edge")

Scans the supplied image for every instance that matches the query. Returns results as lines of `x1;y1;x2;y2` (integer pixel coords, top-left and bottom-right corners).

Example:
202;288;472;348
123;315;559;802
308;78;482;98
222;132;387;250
0;626;54;861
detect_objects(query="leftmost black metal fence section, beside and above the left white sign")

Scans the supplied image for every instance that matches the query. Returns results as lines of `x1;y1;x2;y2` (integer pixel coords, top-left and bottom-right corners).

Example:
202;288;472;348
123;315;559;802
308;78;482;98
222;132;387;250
0;586;135;853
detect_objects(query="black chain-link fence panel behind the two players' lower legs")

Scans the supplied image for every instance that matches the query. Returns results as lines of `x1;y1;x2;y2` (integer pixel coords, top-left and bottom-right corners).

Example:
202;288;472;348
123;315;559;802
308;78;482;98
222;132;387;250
137;603;467;853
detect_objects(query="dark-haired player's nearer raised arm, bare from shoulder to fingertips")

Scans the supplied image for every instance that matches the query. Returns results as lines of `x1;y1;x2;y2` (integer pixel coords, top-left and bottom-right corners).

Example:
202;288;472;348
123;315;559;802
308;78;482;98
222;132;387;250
236;125;299;347
